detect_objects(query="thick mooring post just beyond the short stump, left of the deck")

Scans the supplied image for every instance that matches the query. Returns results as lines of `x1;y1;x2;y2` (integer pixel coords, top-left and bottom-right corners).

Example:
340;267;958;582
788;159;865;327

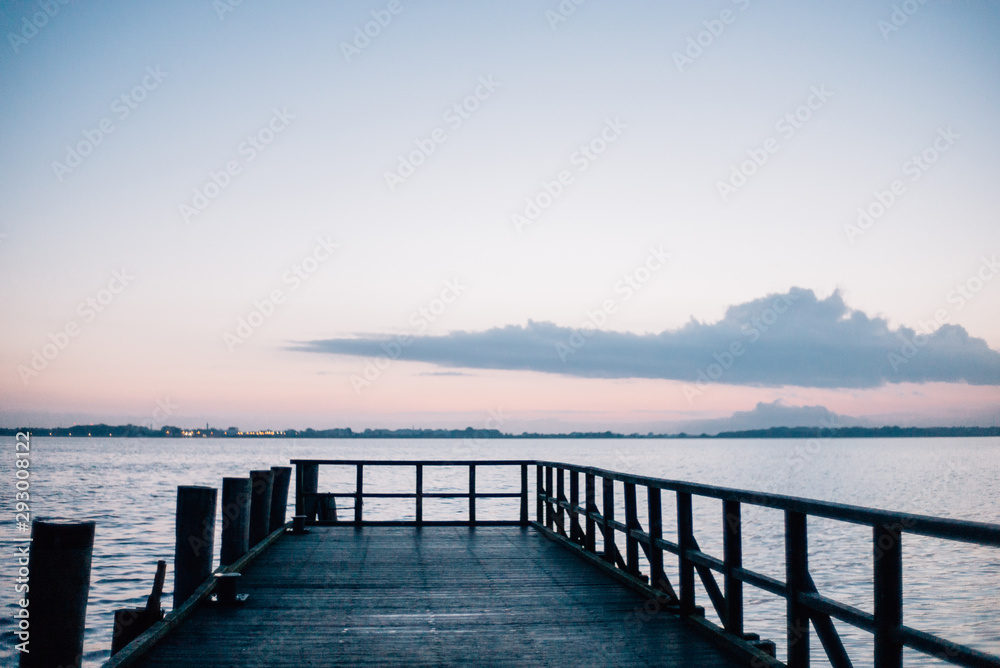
174;485;216;610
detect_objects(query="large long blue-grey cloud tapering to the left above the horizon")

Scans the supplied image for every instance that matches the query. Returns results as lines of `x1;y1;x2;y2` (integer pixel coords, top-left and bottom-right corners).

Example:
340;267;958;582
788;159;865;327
293;288;1000;388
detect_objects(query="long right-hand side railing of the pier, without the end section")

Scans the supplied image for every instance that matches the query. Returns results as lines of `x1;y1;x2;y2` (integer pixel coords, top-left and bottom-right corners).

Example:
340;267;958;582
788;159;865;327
535;461;1000;668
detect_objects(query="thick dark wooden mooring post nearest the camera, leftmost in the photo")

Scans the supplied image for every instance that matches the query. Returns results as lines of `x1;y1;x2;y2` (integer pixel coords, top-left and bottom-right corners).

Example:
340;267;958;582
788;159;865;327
19;519;94;668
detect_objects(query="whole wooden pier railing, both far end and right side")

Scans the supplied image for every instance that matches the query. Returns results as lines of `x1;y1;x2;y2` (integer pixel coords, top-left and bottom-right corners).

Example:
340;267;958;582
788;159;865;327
292;460;1000;668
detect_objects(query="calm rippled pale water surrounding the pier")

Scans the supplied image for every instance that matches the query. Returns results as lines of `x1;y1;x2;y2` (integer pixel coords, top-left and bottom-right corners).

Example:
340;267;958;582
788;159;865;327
0;437;1000;666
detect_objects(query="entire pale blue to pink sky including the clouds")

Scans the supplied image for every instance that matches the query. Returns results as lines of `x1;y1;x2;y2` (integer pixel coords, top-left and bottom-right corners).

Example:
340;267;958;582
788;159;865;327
0;0;1000;433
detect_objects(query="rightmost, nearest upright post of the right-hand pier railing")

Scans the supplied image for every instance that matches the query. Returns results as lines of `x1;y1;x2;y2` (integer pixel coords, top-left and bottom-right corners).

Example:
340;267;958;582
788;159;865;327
872;524;903;668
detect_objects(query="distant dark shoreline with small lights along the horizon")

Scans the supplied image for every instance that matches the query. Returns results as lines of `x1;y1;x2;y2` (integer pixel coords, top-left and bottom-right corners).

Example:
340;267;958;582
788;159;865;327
0;424;1000;439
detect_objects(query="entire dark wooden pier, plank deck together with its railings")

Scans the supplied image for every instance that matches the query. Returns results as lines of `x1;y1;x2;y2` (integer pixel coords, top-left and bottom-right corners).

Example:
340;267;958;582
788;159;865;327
106;460;1000;668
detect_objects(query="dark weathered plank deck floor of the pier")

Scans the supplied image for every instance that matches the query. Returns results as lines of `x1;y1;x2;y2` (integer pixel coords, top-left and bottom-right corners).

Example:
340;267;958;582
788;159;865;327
136;527;739;668
